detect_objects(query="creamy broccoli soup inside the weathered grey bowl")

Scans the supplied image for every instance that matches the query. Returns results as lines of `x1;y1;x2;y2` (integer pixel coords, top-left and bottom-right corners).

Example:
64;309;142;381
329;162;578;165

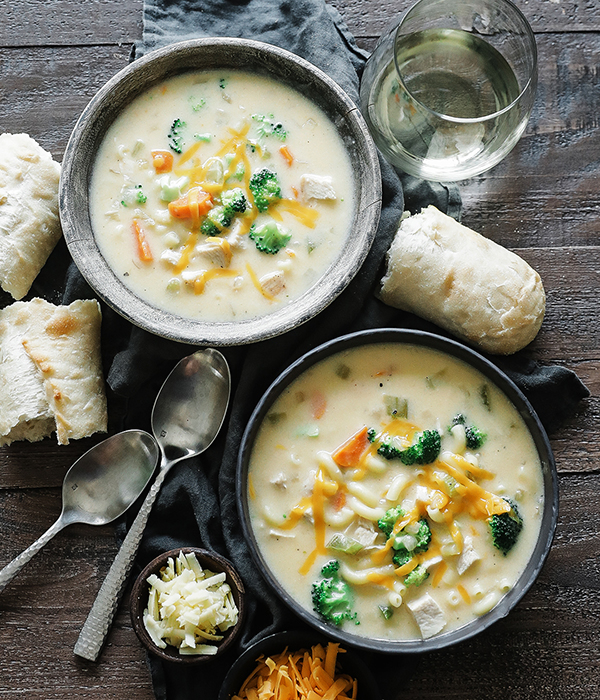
90;71;353;321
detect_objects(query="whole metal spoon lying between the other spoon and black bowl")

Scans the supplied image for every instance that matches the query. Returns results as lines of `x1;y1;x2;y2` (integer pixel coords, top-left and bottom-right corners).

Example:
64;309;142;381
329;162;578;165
74;348;231;661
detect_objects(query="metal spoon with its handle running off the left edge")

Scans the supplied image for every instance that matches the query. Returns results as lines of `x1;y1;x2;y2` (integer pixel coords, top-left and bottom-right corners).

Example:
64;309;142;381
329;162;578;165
0;430;158;591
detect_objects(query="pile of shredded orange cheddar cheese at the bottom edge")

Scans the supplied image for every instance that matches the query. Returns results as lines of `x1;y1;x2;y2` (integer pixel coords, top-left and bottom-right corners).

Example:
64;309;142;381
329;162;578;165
231;642;358;700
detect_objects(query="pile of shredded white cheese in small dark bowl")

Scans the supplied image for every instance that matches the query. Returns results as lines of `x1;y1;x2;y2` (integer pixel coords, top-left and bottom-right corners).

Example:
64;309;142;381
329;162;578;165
143;552;238;654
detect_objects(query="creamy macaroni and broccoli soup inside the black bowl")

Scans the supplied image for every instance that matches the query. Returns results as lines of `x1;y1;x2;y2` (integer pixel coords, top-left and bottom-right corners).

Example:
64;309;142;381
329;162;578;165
248;344;543;640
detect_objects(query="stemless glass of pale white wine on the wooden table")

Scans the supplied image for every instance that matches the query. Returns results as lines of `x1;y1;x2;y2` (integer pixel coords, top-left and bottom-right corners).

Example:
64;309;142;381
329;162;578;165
360;0;537;182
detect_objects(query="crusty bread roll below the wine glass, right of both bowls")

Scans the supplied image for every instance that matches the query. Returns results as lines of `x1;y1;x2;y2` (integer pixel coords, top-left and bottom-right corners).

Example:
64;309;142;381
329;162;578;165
378;206;546;355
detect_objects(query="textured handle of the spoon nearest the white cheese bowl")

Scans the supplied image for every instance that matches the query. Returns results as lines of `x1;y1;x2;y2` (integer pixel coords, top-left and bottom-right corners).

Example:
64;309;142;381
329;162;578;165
74;467;168;661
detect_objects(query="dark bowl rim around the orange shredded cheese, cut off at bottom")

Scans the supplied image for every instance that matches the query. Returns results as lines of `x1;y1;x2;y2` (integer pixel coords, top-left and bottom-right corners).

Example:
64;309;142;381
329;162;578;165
217;630;381;700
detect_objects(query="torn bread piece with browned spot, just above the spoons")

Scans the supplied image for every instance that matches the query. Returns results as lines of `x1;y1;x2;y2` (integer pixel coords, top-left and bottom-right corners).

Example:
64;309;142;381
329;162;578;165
0;299;107;445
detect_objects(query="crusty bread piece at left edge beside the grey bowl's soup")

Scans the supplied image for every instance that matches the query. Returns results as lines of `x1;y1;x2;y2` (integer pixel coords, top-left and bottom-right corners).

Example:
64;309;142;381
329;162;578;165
0;134;61;299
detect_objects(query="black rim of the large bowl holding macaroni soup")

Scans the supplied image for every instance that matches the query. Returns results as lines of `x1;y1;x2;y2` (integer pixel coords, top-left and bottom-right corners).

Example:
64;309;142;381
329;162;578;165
236;328;558;653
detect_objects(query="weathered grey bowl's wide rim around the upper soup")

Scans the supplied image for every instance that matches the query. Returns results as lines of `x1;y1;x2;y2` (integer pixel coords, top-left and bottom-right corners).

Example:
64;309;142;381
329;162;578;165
59;37;382;346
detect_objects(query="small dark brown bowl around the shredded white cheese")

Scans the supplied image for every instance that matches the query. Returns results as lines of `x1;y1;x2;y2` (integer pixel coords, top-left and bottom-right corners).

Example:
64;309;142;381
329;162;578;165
130;547;246;665
